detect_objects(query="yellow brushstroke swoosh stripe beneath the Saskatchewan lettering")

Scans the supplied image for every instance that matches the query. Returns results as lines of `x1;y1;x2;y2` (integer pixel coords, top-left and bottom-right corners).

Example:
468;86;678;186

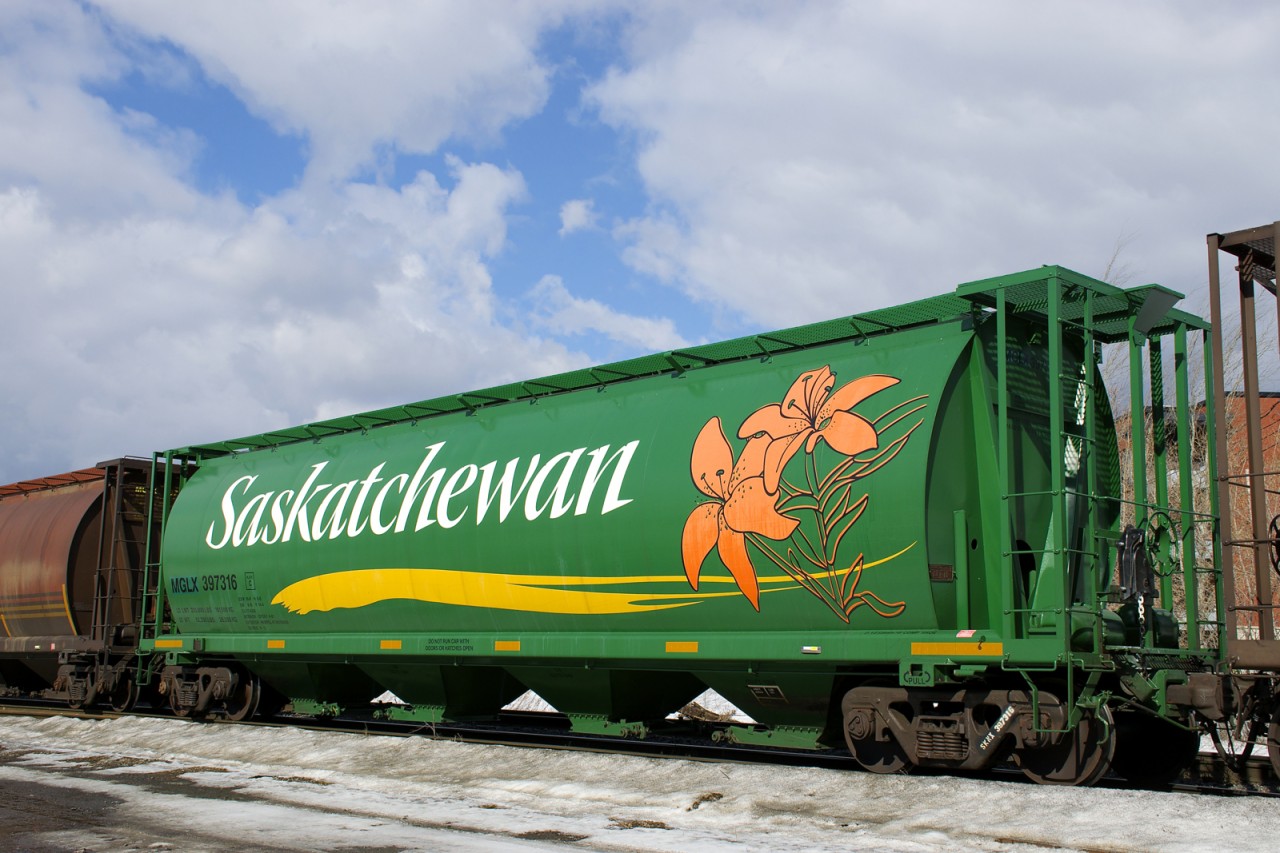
271;543;914;615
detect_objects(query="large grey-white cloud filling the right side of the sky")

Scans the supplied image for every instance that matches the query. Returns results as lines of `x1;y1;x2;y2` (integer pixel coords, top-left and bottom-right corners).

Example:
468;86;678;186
589;1;1280;325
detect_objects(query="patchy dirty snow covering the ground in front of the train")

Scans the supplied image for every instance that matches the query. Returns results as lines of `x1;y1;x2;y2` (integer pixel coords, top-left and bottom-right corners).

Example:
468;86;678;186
0;717;1280;853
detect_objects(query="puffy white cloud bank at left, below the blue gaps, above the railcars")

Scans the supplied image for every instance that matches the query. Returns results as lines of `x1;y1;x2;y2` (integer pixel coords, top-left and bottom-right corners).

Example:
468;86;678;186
0;165;581;479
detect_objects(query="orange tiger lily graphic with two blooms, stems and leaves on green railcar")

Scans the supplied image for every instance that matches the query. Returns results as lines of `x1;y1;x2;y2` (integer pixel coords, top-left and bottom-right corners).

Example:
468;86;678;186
681;365;925;622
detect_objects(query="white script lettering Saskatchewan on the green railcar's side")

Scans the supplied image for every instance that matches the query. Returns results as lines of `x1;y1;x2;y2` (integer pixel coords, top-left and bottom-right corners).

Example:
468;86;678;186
205;441;640;549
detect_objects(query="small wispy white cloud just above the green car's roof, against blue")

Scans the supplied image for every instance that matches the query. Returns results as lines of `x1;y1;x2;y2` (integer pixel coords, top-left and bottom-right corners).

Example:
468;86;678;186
530;275;689;352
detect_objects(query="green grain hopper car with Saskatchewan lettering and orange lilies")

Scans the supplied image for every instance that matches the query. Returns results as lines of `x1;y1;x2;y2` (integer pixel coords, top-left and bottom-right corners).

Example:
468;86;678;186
141;266;1221;783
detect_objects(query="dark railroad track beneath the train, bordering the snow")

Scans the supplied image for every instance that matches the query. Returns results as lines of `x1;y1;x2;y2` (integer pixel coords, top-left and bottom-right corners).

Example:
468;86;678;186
0;698;1280;798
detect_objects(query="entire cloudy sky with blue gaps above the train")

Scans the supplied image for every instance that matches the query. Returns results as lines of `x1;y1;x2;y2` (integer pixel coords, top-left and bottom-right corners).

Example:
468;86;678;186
0;0;1280;483
